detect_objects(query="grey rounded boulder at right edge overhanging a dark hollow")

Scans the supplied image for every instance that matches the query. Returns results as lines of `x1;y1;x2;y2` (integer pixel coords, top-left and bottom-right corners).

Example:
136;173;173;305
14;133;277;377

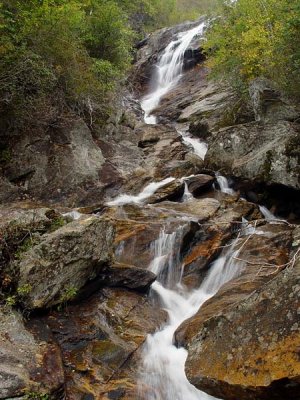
205;121;300;189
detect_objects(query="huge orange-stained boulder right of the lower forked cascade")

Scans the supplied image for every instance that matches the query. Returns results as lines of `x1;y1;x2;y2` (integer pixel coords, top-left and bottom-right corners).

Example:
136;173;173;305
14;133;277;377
176;225;300;400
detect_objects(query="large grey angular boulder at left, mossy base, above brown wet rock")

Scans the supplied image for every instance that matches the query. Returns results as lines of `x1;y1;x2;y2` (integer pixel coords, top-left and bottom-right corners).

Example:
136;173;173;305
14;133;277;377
14;217;114;309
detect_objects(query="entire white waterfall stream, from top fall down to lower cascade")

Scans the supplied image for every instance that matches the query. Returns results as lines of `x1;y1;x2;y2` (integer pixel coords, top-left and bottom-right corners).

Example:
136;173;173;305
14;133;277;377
122;22;242;400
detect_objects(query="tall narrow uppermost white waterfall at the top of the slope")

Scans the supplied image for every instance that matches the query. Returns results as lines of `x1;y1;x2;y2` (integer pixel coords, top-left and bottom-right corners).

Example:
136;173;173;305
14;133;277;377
141;22;205;124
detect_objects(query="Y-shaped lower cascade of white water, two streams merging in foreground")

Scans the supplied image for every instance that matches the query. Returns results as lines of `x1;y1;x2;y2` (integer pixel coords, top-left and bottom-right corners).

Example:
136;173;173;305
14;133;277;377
138;231;243;400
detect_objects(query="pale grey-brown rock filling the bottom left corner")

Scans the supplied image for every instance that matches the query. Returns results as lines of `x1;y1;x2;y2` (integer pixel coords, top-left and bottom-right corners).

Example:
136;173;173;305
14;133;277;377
0;307;64;399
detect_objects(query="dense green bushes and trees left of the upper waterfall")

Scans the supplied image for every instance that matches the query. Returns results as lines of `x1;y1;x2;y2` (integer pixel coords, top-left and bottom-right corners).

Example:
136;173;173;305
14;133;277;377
0;0;217;136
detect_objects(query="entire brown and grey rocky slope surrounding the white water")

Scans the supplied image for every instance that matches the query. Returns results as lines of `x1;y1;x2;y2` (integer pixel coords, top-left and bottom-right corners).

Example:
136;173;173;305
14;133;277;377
0;18;300;400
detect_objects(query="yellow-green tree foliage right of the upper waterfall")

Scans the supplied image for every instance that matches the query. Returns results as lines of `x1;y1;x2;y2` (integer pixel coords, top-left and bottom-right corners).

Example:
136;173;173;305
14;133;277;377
205;0;300;97
